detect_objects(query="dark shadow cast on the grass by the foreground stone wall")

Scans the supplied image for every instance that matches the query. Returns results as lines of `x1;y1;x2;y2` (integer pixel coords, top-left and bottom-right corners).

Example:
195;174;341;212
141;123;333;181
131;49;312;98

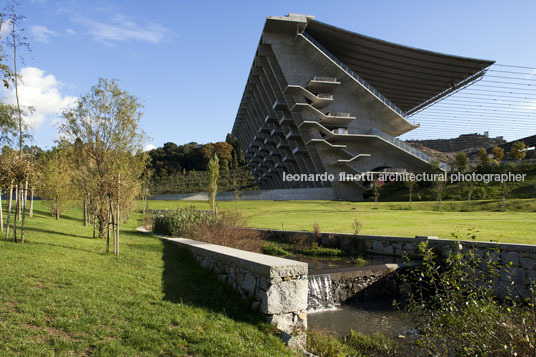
162;240;264;323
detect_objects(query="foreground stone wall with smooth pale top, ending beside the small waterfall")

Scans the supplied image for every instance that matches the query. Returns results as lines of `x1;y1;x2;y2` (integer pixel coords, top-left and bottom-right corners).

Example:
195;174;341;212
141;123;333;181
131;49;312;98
161;237;307;343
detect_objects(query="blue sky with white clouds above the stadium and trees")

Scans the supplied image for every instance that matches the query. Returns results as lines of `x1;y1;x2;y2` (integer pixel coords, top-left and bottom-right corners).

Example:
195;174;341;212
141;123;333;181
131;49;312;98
4;0;536;147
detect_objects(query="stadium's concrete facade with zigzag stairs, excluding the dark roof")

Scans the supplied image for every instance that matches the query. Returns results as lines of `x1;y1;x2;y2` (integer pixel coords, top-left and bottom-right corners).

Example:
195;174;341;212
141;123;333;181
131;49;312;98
232;14;492;200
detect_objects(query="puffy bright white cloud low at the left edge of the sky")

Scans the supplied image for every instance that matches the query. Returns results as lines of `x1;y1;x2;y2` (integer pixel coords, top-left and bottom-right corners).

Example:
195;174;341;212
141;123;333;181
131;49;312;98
2;67;77;129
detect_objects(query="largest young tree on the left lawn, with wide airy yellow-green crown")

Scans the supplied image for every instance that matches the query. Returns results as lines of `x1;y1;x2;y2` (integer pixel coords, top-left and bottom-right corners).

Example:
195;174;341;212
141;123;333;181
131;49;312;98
60;78;147;254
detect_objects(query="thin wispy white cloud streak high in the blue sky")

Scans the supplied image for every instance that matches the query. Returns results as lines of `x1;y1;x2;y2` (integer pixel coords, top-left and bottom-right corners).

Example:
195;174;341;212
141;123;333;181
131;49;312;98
72;14;173;44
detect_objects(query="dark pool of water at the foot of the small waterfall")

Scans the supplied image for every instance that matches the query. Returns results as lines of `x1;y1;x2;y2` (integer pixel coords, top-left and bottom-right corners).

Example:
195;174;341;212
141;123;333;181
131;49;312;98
307;302;413;337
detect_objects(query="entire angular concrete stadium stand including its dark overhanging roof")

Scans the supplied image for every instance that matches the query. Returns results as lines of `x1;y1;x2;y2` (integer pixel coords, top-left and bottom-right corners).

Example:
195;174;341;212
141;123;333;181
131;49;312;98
232;14;493;200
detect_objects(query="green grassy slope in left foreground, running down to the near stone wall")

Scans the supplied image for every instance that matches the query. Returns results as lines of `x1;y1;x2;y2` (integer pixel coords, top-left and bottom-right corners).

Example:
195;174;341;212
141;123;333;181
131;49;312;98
0;202;291;356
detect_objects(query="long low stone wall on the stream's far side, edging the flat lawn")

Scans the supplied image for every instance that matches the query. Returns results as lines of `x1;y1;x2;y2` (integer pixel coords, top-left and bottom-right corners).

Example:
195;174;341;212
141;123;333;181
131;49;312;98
259;229;536;298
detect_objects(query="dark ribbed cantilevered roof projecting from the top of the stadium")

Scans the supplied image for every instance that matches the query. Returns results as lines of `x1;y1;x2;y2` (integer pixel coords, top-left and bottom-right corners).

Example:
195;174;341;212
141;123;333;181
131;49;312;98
305;18;495;114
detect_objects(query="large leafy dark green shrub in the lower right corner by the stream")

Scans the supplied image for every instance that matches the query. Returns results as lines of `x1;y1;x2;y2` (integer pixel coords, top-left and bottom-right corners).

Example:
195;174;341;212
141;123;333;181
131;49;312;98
405;232;536;356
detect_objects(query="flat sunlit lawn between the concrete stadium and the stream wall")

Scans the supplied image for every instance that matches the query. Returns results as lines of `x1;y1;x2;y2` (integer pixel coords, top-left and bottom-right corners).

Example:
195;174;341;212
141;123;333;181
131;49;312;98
149;199;536;244
